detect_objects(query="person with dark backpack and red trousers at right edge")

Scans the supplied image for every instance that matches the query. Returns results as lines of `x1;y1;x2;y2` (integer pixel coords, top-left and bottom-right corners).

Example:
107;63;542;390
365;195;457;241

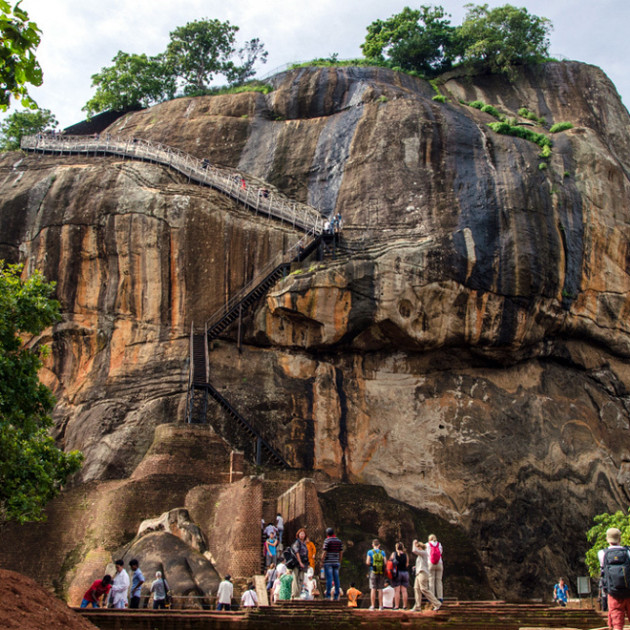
598;527;630;630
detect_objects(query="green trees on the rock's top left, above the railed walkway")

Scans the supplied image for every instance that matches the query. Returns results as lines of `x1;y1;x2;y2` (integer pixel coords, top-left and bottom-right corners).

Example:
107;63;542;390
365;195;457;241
83;19;267;115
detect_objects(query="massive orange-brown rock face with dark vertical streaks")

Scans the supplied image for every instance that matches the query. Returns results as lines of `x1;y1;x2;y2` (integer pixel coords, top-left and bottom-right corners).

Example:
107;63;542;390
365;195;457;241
0;62;630;597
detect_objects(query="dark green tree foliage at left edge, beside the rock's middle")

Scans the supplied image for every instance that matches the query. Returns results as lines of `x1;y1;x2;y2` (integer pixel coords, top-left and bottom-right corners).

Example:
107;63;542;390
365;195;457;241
0;261;82;523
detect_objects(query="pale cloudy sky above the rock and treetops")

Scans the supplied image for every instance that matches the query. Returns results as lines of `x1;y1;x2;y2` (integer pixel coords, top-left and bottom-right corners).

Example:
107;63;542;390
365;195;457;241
6;0;630;127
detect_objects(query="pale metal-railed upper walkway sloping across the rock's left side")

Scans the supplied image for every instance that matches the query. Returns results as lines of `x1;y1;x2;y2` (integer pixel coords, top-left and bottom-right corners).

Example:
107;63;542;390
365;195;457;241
21;134;324;234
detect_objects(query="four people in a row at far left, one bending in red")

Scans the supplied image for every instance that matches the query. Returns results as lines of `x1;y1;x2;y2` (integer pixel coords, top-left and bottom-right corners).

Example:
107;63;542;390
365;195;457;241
81;559;170;610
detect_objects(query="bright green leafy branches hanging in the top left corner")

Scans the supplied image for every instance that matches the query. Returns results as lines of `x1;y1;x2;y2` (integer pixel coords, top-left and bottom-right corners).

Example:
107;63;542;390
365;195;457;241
0;0;43;111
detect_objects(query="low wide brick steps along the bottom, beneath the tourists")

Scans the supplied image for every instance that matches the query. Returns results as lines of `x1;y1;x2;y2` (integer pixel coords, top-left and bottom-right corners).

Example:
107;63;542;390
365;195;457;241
80;600;606;630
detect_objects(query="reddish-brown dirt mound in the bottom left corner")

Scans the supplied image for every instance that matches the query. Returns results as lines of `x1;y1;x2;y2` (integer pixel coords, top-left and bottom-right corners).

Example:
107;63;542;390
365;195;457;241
0;569;96;630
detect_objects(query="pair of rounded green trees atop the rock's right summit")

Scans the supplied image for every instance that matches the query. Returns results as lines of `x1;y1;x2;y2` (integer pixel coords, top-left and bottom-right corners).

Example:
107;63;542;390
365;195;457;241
361;4;551;77
